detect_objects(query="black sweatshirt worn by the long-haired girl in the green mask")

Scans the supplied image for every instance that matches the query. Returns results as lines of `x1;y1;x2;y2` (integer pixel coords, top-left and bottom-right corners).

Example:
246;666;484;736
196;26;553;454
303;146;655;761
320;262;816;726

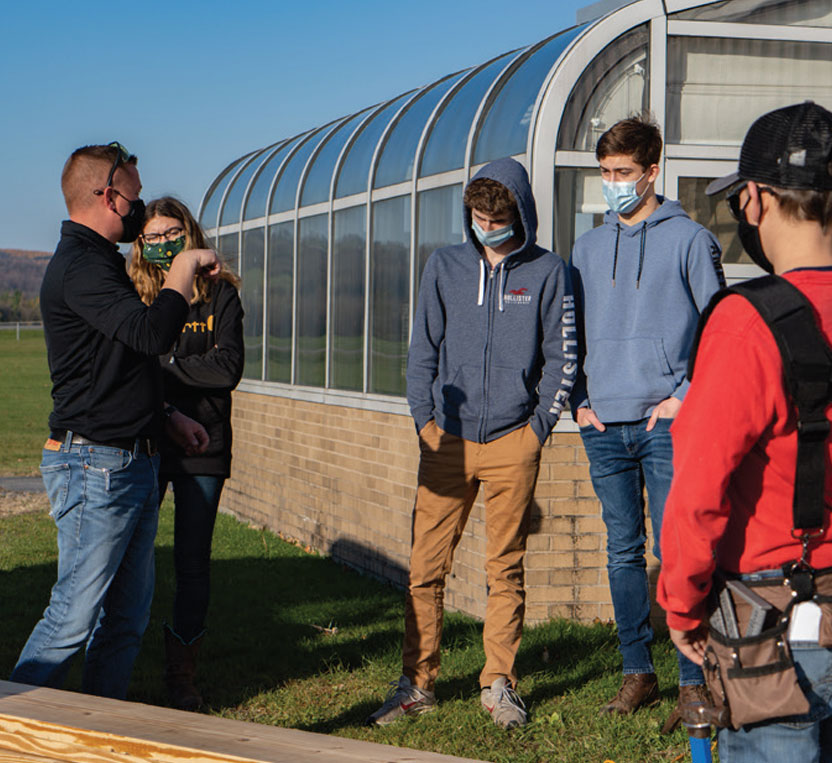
160;281;244;477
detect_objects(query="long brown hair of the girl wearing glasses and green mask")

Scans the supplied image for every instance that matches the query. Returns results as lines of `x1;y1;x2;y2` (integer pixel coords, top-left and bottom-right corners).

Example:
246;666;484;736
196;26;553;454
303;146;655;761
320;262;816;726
128;196;240;305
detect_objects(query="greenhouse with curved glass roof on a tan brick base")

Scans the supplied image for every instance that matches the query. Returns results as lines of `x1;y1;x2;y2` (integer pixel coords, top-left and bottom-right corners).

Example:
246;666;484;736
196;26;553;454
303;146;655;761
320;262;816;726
199;0;832;620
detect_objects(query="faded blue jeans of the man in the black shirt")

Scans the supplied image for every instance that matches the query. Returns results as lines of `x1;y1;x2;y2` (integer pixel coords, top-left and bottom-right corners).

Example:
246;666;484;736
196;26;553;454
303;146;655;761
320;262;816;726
11;445;159;699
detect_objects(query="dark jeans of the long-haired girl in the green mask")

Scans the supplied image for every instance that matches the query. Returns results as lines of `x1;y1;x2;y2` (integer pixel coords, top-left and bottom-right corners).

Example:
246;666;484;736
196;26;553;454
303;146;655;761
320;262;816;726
159;474;225;643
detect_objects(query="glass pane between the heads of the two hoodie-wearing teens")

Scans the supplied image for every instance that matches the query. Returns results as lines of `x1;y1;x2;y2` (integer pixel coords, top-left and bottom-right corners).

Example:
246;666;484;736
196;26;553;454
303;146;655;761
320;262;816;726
555;169;607;261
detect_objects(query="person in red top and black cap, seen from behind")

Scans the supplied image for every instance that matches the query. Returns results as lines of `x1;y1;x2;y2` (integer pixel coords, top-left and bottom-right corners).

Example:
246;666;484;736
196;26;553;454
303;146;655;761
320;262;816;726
658;102;832;763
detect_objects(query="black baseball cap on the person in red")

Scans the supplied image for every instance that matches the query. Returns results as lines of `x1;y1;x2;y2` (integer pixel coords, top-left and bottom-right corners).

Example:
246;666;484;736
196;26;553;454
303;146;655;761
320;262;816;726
705;101;832;196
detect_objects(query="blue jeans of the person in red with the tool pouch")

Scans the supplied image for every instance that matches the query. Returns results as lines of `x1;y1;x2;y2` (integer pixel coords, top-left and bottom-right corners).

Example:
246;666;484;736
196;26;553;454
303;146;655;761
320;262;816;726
717;644;832;763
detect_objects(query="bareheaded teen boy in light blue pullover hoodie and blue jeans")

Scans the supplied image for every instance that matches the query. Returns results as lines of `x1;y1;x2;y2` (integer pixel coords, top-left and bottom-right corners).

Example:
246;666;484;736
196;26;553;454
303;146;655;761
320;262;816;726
570;118;724;729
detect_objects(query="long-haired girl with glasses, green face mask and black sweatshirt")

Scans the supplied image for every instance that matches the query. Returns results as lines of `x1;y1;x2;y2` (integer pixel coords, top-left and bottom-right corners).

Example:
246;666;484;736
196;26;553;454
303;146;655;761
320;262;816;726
129;197;243;710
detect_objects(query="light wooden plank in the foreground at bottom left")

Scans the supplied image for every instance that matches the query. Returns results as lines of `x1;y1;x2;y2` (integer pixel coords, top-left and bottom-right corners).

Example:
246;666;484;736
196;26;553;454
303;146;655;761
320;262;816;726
0;681;484;763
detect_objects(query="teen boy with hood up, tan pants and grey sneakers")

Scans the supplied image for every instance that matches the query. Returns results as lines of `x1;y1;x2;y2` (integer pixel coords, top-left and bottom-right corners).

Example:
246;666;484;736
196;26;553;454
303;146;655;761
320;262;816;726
368;159;577;728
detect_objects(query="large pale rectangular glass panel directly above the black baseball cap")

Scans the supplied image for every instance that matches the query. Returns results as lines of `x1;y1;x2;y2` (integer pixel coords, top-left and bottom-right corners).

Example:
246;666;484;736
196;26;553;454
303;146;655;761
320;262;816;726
666;37;832;146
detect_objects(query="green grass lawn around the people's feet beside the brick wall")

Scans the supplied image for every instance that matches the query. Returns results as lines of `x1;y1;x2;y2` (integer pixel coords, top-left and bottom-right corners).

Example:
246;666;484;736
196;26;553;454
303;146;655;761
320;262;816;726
0;332;716;763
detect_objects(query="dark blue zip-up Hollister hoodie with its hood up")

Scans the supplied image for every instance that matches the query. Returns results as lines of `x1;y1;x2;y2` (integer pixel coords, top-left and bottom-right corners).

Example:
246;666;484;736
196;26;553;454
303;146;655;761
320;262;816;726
407;159;578;442
